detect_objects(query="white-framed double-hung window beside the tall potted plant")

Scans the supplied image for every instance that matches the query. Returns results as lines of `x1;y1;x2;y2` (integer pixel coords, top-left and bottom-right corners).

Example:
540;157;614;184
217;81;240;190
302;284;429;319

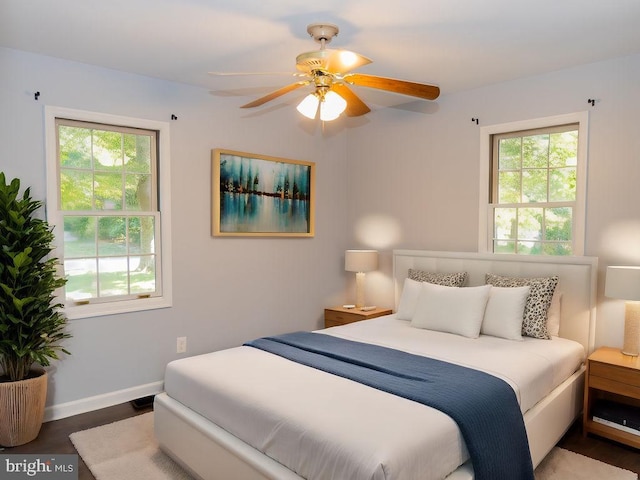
47;109;170;317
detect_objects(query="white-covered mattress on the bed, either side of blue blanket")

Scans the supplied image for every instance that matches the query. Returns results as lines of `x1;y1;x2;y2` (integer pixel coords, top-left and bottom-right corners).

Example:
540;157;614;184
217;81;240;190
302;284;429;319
165;315;584;480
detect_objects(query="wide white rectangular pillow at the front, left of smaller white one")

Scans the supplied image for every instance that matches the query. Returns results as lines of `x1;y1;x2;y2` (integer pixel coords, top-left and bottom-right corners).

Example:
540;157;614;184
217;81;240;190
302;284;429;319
411;283;491;338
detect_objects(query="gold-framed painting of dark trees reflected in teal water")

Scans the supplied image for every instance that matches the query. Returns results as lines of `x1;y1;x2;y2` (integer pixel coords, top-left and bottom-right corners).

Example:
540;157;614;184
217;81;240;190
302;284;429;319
211;149;315;237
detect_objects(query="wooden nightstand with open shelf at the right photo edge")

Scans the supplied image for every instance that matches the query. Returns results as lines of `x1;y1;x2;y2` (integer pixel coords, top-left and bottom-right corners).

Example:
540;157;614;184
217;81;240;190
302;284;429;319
582;347;640;448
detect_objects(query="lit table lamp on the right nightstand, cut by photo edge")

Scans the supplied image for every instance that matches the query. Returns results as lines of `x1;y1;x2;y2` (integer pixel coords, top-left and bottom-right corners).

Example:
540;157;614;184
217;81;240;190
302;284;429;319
604;267;640;357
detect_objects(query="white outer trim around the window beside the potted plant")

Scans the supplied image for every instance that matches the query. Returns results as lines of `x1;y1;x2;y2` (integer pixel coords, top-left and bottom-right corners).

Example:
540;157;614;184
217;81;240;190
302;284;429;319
45;106;172;319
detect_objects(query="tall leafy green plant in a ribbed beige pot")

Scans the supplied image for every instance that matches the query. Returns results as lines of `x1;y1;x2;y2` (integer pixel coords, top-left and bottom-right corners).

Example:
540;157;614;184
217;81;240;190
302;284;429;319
0;172;71;447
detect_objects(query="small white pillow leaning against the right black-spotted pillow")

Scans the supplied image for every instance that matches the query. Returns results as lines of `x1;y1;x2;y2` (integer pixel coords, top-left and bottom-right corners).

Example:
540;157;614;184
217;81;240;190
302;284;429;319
480;286;531;340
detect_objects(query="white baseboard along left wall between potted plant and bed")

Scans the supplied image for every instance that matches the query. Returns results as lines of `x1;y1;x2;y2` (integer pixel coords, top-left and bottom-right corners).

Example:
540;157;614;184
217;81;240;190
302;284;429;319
44;381;164;422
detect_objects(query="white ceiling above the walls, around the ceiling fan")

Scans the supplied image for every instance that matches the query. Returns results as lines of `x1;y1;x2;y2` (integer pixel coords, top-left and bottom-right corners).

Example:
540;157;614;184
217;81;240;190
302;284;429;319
0;0;640;104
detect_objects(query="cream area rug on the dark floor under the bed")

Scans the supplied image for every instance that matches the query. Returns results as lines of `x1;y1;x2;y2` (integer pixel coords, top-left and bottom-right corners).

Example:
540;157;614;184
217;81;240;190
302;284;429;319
69;413;638;480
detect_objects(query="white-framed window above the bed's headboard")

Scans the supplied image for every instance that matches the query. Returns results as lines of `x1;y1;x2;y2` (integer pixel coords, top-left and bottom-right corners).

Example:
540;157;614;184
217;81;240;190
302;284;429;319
480;114;587;255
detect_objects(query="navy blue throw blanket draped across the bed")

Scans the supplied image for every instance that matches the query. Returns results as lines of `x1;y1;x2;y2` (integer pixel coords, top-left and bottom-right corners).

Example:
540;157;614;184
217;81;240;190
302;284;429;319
245;332;534;480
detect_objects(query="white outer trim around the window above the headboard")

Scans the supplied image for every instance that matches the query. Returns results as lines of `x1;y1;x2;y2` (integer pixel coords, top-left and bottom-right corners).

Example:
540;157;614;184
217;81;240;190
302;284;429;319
478;111;589;256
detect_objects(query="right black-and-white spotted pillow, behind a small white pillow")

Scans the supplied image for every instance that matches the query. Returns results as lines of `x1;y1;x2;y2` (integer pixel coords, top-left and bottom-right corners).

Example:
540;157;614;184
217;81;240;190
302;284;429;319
485;273;558;340
